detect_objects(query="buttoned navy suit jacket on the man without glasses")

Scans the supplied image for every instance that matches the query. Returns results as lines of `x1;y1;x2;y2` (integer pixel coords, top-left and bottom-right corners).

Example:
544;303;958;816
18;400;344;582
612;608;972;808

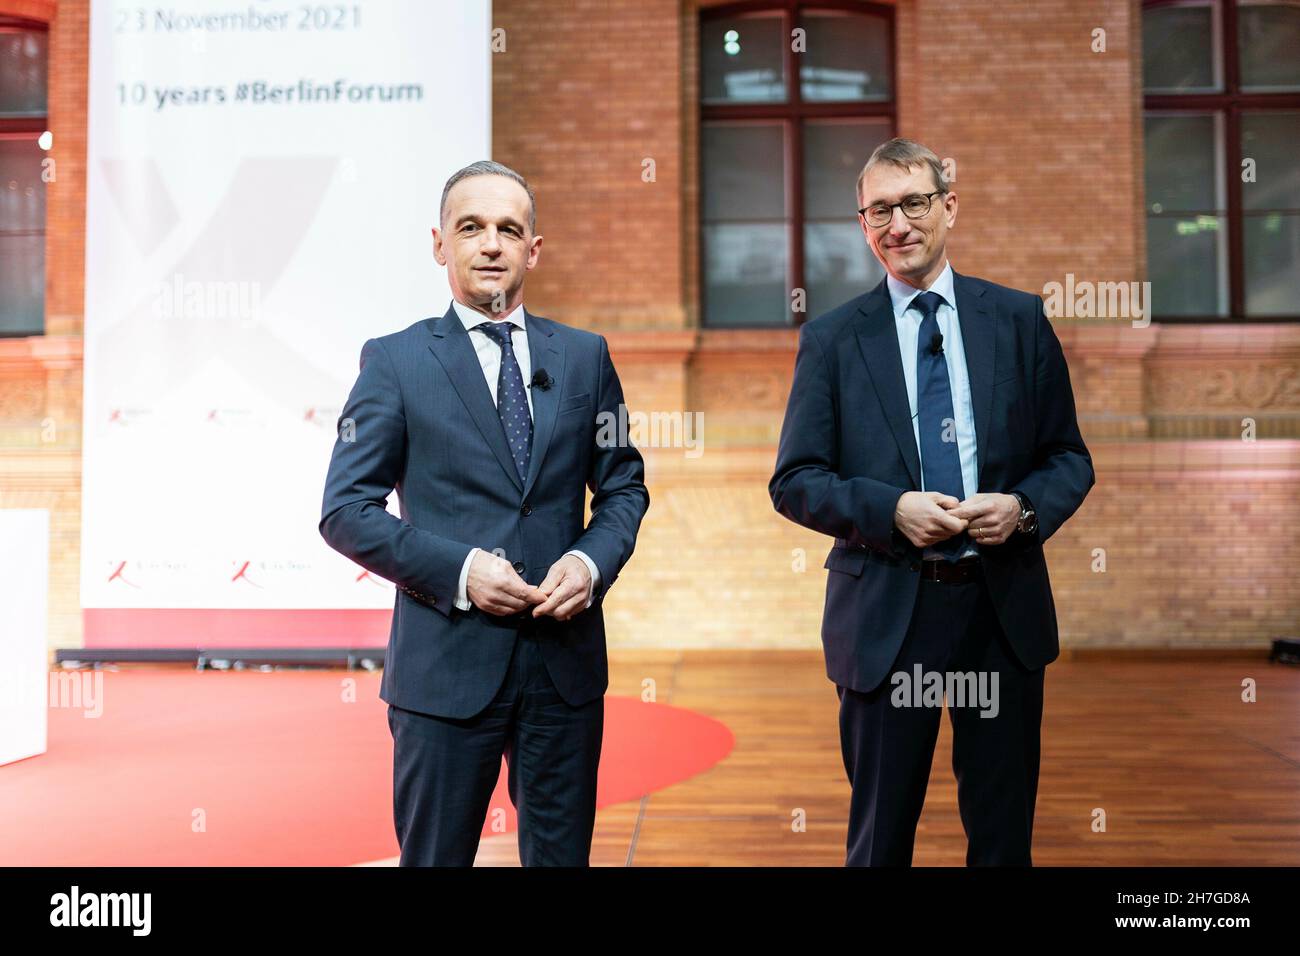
320;308;650;718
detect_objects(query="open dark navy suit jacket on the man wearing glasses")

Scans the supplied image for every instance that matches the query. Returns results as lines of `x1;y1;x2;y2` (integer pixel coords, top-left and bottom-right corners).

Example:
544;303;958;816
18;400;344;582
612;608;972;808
768;273;1095;692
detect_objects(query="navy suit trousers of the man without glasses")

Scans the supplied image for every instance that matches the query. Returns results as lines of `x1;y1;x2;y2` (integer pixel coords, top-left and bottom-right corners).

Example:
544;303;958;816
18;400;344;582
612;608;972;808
389;623;605;866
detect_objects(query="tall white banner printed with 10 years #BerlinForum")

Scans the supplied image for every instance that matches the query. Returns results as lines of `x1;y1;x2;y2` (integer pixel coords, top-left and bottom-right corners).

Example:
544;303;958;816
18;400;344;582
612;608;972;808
82;0;491;609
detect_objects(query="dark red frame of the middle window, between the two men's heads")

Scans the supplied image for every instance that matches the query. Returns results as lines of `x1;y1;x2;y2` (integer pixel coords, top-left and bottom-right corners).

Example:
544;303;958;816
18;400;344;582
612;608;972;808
696;0;898;330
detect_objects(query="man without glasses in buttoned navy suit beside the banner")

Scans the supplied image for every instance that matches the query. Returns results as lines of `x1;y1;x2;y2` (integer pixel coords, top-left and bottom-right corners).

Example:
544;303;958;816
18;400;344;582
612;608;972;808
320;161;650;866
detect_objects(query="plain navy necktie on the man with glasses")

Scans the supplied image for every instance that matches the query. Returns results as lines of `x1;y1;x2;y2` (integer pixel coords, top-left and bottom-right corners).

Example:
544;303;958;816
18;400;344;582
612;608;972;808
909;293;970;561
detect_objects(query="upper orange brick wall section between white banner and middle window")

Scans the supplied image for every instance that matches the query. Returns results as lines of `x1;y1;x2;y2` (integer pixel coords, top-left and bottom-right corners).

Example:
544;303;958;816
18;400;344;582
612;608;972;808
491;0;685;329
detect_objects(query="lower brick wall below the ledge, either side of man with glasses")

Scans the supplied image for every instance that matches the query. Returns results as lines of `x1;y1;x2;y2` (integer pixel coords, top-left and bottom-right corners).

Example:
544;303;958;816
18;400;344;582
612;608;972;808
606;441;1300;648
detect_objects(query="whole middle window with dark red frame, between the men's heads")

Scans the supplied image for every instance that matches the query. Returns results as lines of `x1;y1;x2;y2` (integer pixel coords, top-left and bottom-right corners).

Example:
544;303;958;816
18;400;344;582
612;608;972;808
699;0;894;328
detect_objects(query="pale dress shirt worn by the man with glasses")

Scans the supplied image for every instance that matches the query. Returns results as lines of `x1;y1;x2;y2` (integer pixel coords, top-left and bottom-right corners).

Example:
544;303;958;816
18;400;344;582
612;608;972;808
885;261;979;559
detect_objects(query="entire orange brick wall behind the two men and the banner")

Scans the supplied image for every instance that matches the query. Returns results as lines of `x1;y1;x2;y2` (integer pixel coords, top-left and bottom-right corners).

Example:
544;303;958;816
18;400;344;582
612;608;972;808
0;0;1300;646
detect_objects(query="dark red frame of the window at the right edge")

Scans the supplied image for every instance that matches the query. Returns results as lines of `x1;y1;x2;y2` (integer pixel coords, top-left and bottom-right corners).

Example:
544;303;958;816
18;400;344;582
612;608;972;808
1140;0;1300;324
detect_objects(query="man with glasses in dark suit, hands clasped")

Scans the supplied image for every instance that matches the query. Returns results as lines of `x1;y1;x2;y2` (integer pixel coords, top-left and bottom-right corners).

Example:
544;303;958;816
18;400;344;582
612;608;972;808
768;139;1095;866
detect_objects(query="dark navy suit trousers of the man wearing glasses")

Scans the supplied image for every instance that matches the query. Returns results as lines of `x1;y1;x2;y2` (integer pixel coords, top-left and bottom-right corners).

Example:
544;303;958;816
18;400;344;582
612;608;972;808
839;576;1045;866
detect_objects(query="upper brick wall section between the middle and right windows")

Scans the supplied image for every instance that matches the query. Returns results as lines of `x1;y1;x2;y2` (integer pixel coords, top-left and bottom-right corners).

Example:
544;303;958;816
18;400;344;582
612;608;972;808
898;0;1145;291
